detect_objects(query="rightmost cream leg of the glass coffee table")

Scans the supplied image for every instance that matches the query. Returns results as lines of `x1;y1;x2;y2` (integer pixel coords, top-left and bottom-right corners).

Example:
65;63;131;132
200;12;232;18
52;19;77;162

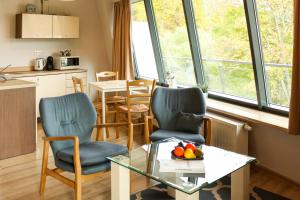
231;164;250;200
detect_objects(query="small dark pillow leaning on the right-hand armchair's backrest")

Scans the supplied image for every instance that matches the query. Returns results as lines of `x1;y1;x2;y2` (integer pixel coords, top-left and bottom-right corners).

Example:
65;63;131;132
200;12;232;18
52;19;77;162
175;112;204;134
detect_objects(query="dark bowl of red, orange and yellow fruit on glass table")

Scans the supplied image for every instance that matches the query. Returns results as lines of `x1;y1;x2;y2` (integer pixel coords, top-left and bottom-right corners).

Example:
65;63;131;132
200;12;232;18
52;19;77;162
171;141;203;160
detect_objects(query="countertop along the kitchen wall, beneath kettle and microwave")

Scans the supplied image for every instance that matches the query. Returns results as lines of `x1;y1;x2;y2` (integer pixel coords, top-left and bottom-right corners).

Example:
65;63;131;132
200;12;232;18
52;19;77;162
5;69;87;78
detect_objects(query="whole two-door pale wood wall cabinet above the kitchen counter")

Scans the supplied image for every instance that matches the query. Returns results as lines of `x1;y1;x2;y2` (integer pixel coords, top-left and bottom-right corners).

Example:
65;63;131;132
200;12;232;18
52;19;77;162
16;14;79;38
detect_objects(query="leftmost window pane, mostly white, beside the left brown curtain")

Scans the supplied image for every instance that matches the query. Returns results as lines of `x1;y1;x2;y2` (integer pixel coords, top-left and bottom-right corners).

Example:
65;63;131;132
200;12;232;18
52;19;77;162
131;1;158;79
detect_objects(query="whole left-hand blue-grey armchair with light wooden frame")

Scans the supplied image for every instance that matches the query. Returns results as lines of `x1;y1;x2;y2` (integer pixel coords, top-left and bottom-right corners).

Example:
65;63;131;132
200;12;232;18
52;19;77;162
39;93;128;200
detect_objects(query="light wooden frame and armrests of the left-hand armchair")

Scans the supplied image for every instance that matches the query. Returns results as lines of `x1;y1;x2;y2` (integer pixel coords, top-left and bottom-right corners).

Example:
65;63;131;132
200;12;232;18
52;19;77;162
39;123;128;200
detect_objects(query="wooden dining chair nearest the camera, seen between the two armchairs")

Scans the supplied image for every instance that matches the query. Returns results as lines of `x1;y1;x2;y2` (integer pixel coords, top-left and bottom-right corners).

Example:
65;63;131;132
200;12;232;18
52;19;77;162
116;80;156;149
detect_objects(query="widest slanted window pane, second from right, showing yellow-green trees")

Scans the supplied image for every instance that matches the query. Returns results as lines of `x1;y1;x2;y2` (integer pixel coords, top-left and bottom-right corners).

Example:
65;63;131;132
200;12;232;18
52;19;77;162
193;0;257;100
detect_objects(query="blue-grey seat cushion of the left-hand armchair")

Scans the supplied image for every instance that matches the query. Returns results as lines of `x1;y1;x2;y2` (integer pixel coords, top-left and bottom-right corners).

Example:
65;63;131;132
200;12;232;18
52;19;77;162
56;142;128;167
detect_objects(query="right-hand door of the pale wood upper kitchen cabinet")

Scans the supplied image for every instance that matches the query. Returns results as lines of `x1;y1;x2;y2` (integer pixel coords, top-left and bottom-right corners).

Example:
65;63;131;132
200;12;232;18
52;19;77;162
53;16;79;38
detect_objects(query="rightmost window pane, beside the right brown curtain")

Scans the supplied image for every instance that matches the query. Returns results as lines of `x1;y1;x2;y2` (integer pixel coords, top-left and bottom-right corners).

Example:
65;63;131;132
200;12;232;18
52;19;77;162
256;0;293;106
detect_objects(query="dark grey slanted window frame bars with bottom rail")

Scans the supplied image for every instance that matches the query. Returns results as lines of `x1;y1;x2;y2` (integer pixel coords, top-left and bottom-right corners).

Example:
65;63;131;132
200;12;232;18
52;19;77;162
131;0;289;116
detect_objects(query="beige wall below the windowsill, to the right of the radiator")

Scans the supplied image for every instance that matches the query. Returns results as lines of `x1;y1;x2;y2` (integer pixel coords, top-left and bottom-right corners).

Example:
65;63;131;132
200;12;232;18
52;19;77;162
249;124;300;184
